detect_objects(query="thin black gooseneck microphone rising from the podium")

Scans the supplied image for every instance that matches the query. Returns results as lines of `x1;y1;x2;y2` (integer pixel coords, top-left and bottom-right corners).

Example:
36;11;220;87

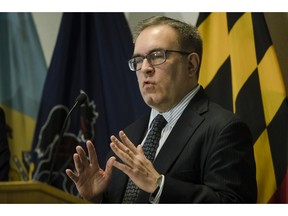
47;91;87;184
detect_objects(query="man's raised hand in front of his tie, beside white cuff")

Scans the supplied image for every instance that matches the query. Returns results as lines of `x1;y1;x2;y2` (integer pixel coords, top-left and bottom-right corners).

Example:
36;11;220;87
110;131;160;193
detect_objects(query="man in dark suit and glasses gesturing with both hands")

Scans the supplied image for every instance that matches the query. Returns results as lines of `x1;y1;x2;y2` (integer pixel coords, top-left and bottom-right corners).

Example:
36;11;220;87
66;17;257;203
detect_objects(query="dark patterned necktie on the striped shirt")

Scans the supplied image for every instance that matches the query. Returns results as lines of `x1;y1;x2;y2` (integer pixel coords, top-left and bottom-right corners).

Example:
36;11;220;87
123;114;167;203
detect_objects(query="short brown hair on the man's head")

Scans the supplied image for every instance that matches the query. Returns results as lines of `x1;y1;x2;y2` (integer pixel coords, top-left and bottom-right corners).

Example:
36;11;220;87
133;16;203;66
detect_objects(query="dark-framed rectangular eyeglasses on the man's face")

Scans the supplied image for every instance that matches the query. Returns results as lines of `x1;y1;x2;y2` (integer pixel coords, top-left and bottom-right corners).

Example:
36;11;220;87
128;50;190;71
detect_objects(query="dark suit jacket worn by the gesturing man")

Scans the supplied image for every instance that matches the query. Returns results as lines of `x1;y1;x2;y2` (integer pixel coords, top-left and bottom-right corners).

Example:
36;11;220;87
103;87;257;203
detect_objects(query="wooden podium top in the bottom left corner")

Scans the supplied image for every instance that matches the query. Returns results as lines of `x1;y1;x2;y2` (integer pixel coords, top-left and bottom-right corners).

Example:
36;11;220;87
0;181;89;204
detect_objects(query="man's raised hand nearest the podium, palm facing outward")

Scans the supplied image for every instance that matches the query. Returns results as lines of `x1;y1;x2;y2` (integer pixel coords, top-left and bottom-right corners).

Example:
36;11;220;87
66;141;116;202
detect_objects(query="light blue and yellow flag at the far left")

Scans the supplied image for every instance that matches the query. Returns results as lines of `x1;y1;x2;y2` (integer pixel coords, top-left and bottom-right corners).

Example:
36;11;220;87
0;13;47;180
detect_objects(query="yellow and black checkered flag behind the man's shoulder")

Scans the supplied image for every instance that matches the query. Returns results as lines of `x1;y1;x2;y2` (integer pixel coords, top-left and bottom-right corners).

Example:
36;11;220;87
197;13;288;203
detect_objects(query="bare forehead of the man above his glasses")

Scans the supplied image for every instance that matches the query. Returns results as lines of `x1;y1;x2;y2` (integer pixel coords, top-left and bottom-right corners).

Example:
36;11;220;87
134;25;179;55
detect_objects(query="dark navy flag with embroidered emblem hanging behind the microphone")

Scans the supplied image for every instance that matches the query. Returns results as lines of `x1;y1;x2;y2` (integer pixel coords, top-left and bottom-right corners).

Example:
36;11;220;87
32;13;147;195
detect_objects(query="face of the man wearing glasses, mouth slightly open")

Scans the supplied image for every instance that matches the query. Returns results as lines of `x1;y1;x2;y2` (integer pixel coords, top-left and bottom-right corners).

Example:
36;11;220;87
134;25;197;112
